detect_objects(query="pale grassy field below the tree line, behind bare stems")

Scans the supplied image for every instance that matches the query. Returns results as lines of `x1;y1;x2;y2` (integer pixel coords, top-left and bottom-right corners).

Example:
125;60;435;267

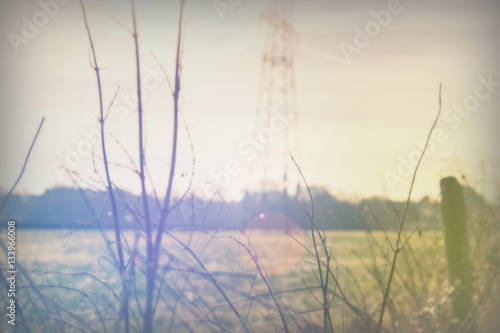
2;230;476;332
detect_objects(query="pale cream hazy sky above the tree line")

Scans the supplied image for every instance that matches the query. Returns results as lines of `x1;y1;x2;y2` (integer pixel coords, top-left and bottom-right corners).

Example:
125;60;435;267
0;0;500;200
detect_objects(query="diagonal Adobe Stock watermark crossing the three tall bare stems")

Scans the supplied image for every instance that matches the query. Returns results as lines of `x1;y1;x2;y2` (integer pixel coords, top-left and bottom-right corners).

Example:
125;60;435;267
51;64;165;181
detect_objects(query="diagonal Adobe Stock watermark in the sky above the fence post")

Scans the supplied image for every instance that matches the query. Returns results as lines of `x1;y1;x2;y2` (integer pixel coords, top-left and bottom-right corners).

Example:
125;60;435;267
384;74;500;192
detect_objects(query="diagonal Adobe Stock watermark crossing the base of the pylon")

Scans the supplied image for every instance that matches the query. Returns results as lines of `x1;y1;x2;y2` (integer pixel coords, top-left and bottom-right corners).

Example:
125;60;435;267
180;109;295;222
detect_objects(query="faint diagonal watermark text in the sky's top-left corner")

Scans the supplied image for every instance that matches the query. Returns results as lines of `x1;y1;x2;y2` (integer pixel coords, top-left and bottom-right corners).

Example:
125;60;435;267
7;0;70;53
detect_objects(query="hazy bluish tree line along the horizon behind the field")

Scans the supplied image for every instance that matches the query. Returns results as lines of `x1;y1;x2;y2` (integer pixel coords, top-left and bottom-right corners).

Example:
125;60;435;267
0;187;474;230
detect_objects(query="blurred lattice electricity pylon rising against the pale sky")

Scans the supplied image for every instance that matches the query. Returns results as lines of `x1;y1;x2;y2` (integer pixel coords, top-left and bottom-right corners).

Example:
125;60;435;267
250;0;299;208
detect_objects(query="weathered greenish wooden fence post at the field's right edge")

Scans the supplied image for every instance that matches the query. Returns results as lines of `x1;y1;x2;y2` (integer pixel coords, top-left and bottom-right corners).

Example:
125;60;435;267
441;177;474;324
